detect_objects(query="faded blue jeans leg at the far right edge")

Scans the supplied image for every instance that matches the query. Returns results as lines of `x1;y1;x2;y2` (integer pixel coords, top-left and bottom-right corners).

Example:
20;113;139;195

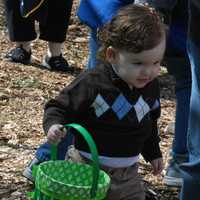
180;40;200;200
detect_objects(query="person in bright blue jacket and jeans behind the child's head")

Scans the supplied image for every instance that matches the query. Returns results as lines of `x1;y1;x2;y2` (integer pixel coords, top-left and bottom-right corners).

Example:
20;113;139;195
77;0;134;69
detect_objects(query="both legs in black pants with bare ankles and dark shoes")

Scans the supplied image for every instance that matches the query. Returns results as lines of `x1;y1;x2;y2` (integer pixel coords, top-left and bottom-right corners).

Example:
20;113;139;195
4;0;72;72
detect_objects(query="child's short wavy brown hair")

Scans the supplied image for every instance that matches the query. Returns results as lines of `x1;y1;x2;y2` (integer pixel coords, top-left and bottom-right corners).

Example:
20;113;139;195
98;4;165;57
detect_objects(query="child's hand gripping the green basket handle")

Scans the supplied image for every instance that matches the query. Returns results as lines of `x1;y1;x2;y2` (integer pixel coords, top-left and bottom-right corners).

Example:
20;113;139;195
47;124;67;144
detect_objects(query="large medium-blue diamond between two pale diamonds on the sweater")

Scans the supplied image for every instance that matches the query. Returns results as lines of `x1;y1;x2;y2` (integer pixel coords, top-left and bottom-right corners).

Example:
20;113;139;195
112;94;132;119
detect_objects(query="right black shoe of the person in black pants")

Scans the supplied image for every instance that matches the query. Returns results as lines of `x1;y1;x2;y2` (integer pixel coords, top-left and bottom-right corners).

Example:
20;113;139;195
43;54;72;72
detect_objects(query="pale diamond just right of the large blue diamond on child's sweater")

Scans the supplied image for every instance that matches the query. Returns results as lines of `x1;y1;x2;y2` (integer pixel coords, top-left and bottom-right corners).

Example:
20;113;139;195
134;96;150;122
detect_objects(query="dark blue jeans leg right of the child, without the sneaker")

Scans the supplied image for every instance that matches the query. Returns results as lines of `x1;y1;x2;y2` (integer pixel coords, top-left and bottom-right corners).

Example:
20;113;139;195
168;65;191;157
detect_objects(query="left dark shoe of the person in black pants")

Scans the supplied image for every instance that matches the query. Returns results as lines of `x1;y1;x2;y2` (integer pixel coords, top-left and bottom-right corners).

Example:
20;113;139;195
5;45;31;64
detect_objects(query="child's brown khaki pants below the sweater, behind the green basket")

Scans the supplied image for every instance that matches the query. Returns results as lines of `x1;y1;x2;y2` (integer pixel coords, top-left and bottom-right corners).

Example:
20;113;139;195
68;148;145;200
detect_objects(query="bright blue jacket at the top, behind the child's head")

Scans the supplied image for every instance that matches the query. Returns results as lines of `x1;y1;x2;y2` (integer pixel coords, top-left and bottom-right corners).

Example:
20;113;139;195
77;0;134;29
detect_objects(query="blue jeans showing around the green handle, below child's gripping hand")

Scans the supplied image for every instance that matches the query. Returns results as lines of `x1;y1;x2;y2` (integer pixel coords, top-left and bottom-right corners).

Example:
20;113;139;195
35;133;73;162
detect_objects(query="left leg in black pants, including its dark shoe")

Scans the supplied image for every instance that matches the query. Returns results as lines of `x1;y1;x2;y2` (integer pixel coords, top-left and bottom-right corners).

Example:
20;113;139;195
4;0;37;64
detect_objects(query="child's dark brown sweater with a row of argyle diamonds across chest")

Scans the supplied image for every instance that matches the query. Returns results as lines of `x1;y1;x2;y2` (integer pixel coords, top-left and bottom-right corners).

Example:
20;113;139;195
43;64;161;161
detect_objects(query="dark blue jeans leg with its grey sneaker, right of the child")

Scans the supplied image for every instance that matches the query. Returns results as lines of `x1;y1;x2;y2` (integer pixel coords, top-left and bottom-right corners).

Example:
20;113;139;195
164;59;191;186
